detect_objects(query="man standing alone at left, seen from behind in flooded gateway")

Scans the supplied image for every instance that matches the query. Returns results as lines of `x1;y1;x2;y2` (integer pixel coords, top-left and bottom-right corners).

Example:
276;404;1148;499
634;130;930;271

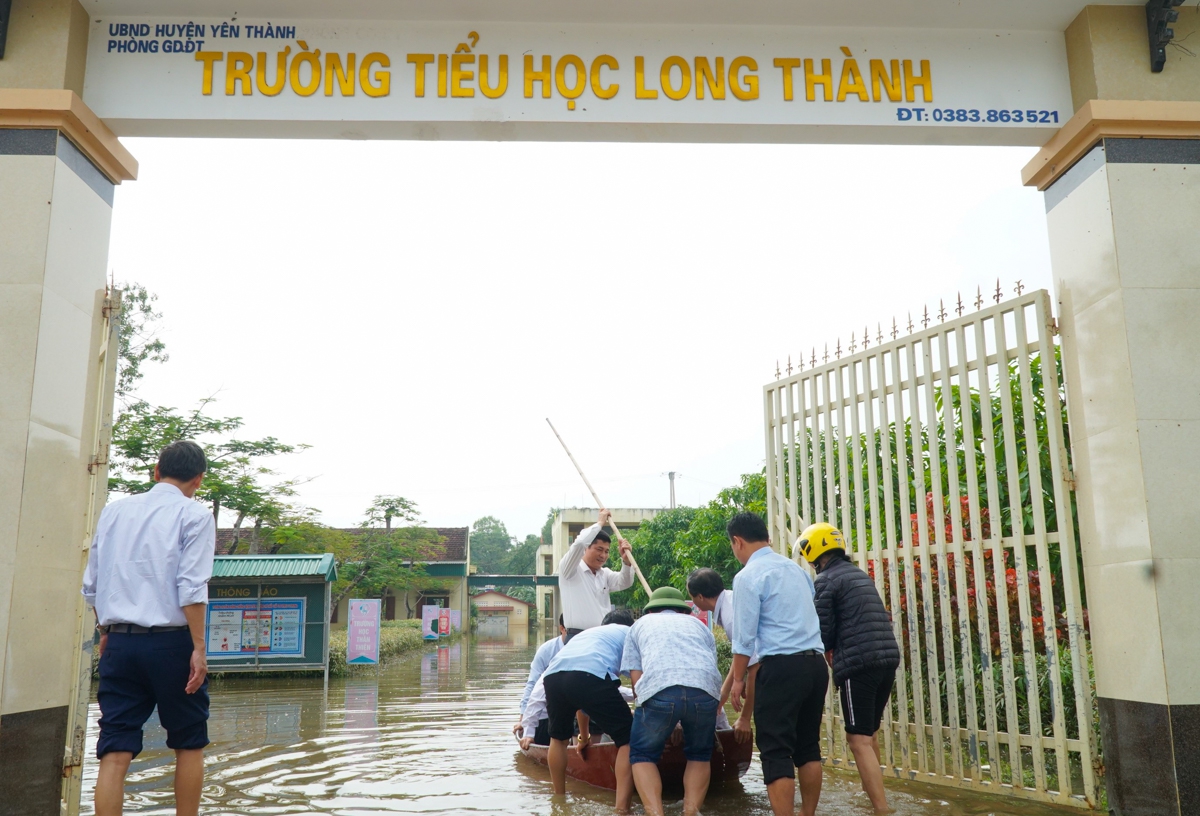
83;442;216;816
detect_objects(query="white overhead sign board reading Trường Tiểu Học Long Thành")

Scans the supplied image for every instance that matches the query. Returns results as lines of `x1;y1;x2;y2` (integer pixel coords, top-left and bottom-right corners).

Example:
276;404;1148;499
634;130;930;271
84;14;1073;145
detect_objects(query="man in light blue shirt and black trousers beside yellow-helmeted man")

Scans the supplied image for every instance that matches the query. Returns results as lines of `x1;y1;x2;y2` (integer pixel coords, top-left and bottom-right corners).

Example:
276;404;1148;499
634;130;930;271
727;512;829;816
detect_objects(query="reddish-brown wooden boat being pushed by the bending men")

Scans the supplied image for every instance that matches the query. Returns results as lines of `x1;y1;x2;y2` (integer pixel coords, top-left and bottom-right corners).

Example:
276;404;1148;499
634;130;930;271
521;728;754;791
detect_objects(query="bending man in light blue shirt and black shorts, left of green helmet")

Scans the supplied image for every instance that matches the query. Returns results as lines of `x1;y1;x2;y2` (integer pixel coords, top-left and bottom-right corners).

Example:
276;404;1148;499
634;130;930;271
541;610;634;812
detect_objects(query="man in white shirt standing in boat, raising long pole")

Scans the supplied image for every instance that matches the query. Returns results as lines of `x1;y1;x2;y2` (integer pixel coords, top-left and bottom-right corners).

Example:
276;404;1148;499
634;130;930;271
558;508;634;642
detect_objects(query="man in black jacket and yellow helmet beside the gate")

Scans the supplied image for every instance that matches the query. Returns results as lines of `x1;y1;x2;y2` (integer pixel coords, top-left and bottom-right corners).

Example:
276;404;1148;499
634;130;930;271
796;522;900;814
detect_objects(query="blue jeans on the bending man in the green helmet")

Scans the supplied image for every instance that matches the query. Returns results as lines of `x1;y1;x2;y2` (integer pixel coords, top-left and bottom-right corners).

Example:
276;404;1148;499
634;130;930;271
629;685;719;764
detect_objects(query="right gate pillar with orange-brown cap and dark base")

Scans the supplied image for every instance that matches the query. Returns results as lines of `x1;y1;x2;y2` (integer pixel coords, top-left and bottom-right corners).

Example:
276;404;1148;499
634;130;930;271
1026;102;1200;816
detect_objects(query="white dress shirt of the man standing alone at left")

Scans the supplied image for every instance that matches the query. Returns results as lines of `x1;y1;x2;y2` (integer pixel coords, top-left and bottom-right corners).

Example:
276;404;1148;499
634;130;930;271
83;481;217;626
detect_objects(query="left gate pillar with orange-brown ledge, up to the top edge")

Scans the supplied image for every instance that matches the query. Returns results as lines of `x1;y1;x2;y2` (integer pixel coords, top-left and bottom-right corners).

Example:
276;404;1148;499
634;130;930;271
0;0;137;816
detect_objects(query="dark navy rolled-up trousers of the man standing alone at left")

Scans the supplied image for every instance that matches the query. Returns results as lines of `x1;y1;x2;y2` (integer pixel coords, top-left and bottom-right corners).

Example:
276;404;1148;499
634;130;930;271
96;629;209;757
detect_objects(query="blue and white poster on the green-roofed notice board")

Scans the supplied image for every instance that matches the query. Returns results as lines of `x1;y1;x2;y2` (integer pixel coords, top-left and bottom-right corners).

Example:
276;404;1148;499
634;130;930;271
205;598;306;660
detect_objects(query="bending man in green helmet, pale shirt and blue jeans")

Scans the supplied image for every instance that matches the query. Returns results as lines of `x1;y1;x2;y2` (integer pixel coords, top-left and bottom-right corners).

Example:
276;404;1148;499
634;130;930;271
620;587;721;816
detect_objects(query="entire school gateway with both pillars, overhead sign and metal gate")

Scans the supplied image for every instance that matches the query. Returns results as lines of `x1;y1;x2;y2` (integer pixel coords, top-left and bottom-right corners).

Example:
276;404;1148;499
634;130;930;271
0;0;1200;815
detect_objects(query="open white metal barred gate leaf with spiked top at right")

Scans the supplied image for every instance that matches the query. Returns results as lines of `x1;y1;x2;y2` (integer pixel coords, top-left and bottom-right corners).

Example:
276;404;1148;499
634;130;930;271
764;289;1097;808
